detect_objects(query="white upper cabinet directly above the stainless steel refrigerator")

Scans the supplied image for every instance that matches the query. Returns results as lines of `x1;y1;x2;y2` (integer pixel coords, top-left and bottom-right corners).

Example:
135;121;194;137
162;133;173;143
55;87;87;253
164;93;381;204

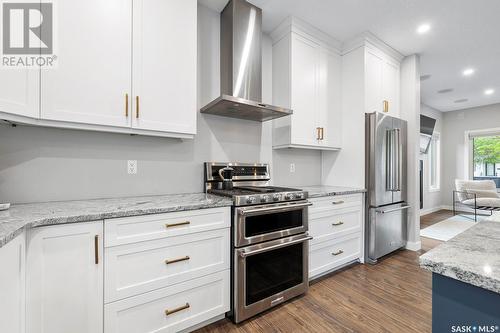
365;46;400;117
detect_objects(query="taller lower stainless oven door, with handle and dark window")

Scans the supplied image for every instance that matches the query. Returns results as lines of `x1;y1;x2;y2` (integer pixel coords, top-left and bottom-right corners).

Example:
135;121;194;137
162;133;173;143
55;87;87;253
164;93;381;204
233;234;312;323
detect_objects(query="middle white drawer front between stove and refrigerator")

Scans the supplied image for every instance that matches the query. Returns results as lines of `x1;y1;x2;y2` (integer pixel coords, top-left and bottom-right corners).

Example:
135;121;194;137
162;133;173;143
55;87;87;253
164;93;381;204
309;207;362;244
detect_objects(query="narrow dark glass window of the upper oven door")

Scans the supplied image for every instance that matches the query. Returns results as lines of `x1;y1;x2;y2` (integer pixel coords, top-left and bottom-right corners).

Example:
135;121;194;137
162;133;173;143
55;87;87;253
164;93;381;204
245;209;304;237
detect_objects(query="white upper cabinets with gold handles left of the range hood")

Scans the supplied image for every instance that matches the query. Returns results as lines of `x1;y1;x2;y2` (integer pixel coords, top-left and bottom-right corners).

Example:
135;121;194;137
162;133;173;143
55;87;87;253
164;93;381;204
0;0;198;138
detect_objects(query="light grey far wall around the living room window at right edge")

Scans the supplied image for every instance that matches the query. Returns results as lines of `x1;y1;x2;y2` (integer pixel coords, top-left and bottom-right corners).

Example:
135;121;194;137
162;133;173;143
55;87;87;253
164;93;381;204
441;104;500;206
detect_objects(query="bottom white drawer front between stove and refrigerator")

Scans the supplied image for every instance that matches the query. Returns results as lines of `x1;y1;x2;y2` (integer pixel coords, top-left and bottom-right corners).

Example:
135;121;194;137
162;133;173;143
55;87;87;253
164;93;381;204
309;234;361;279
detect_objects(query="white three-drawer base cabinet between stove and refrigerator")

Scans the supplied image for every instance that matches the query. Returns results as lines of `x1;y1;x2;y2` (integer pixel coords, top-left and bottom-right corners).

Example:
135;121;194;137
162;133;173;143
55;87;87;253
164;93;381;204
309;194;363;279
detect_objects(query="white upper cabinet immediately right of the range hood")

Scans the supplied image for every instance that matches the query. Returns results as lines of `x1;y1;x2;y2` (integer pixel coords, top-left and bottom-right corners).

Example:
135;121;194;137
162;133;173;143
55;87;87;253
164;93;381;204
271;18;341;150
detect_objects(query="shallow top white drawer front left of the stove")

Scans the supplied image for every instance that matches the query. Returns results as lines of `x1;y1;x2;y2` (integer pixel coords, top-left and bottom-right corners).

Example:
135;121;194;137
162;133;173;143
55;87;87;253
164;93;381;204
104;207;231;247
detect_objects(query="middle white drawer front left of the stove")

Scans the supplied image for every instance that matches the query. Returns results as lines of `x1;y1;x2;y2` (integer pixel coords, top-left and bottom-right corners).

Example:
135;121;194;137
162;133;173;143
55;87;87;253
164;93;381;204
104;228;230;303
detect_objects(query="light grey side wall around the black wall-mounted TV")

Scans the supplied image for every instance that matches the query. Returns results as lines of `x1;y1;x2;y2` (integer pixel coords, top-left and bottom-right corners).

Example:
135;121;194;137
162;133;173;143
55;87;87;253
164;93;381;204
420;104;445;214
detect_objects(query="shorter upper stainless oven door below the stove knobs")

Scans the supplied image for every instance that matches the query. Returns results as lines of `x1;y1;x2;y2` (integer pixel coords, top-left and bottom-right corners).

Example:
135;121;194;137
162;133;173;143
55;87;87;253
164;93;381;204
234;200;312;247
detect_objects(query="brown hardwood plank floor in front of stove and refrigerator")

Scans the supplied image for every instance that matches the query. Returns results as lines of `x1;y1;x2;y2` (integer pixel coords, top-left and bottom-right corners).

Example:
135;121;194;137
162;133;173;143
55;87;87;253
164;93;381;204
197;211;451;333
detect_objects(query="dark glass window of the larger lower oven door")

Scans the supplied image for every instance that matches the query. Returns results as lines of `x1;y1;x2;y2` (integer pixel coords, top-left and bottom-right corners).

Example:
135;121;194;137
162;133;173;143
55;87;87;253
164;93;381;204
245;243;307;305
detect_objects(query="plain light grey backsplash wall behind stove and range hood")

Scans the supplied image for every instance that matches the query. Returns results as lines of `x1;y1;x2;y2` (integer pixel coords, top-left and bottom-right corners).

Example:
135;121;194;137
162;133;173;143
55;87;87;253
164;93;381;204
0;6;321;203
